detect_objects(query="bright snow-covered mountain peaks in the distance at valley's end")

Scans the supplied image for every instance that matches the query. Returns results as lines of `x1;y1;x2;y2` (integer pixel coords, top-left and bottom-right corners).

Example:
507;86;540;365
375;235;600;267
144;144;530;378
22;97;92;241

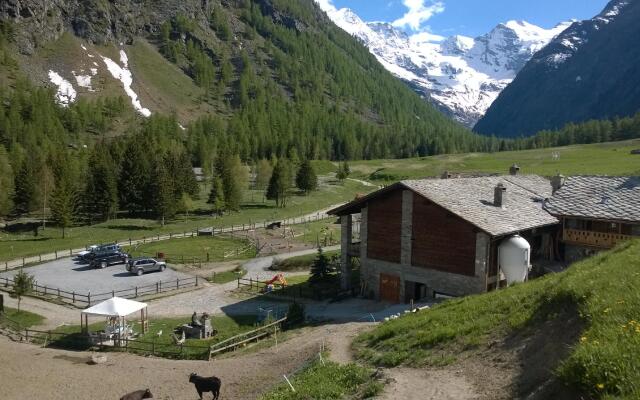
325;8;571;127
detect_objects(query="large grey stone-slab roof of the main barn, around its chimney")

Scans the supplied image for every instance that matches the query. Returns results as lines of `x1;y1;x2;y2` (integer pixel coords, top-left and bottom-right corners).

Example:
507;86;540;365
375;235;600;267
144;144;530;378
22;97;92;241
400;175;558;236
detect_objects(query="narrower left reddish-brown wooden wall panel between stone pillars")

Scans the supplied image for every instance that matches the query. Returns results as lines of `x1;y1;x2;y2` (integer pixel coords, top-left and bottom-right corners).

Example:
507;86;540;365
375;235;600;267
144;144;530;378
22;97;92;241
367;190;402;264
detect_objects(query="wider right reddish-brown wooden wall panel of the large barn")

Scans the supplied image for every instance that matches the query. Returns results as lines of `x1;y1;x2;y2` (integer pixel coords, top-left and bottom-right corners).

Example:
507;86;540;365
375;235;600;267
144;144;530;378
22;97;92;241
411;193;477;276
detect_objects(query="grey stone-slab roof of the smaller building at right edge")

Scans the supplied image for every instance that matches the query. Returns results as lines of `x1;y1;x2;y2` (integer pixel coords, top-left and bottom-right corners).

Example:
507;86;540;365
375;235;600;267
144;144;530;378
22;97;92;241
545;176;640;222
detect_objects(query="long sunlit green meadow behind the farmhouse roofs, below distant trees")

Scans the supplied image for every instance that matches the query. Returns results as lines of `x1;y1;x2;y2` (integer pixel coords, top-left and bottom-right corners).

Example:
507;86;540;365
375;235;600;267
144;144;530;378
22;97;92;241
350;139;640;183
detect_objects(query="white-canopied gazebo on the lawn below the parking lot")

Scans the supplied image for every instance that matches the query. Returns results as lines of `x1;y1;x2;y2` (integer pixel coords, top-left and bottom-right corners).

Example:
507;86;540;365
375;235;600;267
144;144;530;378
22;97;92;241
80;297;149;339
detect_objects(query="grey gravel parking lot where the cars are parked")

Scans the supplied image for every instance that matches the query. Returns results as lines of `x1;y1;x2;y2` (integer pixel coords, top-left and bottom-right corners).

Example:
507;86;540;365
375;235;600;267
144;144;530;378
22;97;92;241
0;258;191;294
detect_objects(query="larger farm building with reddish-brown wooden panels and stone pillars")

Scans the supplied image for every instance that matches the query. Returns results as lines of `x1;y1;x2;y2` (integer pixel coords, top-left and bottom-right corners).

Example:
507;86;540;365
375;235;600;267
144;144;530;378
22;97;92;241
330;173;559;302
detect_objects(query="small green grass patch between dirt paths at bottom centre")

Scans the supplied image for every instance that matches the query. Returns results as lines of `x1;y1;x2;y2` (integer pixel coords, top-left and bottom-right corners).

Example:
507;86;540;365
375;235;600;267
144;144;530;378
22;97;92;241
261;359;382;400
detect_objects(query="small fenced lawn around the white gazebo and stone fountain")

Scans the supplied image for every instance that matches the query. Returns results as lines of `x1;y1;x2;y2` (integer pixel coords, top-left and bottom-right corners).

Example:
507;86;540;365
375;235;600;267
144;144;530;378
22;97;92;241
45;315;257;359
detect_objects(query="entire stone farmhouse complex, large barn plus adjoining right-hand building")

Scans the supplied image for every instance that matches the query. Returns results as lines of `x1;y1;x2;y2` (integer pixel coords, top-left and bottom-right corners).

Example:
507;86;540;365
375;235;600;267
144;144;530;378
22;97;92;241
329;172;640;302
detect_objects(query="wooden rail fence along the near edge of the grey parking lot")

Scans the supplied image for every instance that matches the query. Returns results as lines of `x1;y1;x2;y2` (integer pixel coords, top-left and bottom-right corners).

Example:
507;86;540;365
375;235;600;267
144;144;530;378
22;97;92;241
0;276;200;307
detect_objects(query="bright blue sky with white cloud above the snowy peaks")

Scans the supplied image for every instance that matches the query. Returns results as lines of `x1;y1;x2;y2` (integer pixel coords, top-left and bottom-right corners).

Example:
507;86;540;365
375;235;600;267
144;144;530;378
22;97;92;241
319;0;608;36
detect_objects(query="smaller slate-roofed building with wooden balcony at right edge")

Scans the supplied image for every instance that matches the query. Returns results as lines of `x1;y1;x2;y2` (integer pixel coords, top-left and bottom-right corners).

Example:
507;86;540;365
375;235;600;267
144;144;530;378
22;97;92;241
545;176;640;261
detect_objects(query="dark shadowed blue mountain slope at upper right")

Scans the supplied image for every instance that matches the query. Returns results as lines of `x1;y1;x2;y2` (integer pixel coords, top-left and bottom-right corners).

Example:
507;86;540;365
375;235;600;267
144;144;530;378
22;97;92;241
474;0;640;137
